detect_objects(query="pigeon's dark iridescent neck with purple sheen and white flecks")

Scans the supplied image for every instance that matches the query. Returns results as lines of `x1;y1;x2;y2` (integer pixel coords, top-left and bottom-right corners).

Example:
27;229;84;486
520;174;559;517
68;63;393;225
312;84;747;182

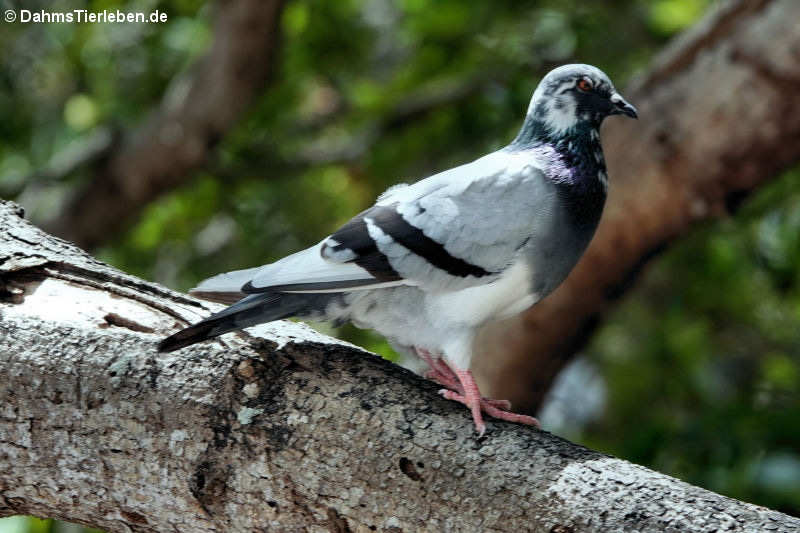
508;115;607;193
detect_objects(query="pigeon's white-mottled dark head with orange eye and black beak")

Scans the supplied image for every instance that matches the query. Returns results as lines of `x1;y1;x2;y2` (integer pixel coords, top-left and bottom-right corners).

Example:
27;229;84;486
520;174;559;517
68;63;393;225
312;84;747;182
528;64;637;135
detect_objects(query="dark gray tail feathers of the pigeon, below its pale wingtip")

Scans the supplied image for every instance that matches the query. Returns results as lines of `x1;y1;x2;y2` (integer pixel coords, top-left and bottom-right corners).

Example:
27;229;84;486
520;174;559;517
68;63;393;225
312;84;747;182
158;292;311;352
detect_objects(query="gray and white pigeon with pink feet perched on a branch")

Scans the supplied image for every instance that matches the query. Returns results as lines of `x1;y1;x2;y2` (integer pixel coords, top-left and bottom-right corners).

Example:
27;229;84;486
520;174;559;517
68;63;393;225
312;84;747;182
159;64;637;435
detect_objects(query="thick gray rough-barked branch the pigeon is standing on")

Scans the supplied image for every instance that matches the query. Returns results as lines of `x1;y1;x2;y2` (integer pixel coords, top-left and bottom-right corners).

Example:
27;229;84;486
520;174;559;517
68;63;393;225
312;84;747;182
0;202;800;532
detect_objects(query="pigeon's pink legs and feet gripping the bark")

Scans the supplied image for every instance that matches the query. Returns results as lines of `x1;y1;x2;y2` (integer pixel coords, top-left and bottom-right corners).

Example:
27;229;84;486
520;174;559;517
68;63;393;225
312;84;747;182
416;348;540;435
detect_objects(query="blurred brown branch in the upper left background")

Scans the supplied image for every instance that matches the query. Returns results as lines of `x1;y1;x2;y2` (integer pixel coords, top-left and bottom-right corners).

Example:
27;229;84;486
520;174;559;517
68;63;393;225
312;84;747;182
48;0;284;247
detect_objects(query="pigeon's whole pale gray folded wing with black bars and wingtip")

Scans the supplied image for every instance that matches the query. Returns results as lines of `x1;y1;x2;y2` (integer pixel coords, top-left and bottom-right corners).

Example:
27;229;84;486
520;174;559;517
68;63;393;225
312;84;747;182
198;151;550;295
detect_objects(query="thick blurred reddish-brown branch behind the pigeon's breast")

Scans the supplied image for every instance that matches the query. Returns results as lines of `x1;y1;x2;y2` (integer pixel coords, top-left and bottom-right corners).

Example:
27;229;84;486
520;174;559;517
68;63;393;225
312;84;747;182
474;0;800;411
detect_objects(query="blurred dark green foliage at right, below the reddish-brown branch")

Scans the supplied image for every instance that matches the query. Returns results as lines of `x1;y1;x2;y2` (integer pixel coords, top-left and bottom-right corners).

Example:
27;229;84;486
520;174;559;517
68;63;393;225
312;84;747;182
581;170;800;515
